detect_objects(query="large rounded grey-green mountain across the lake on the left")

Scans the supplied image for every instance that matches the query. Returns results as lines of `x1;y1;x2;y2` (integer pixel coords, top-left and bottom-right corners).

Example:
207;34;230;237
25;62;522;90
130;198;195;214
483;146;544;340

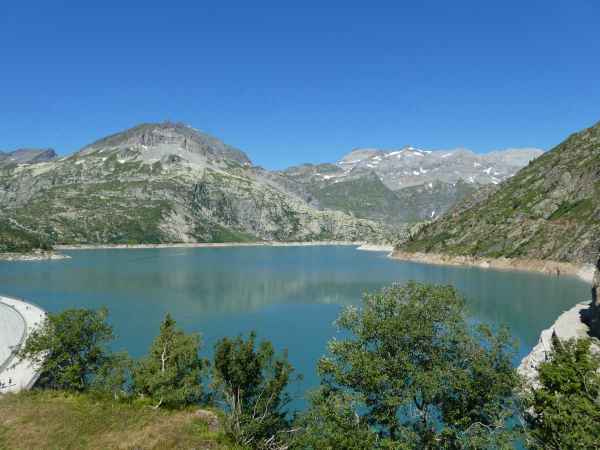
0;122;388;243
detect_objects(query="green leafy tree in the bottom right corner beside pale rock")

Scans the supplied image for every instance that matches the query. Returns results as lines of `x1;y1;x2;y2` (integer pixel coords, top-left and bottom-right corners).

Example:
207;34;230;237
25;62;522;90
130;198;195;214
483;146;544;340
525;337;600;449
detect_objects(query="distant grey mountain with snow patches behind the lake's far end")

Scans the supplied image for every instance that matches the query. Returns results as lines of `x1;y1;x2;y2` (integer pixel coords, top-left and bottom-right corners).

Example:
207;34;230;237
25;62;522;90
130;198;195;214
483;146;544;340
280;147;543;225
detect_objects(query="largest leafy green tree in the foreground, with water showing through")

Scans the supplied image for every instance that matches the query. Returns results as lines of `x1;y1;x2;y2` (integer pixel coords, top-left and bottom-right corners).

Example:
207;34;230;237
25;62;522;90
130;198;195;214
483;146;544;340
304;282;518;449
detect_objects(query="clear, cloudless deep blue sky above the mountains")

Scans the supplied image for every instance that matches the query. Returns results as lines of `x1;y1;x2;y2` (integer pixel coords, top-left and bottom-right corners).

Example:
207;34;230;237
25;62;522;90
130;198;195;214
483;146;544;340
0;0;600;168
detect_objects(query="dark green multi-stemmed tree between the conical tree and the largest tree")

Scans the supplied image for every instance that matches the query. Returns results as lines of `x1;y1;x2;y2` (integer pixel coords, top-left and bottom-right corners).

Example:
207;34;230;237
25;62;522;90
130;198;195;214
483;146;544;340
213;332;294;448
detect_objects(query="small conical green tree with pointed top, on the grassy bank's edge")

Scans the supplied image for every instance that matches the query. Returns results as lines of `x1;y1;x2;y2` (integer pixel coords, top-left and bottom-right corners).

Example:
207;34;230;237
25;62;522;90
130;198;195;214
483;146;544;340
133;314;206;408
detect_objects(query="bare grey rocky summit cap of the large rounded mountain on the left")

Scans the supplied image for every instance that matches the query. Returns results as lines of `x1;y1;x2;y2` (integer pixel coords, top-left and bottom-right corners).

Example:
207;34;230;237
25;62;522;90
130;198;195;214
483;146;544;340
79;122;252;165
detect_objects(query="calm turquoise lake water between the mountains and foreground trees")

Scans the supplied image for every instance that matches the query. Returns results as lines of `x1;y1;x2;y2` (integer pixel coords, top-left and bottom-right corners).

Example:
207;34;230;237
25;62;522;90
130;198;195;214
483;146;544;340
0;246;589;404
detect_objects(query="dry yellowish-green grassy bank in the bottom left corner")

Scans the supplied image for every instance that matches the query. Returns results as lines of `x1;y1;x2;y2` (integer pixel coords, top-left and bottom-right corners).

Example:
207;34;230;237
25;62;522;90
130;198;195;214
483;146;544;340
0;391;236;450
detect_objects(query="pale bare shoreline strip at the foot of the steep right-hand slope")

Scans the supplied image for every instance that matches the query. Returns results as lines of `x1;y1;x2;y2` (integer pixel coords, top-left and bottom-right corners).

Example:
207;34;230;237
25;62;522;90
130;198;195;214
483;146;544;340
390;250;595;284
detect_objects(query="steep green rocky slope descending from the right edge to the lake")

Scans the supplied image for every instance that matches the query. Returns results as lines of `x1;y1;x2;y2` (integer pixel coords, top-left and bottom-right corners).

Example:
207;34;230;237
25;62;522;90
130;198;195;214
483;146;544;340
400;122;600;263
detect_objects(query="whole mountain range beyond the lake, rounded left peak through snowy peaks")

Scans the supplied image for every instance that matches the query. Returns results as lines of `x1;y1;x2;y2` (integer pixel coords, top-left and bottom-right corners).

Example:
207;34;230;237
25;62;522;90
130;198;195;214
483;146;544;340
0;122;541;251
